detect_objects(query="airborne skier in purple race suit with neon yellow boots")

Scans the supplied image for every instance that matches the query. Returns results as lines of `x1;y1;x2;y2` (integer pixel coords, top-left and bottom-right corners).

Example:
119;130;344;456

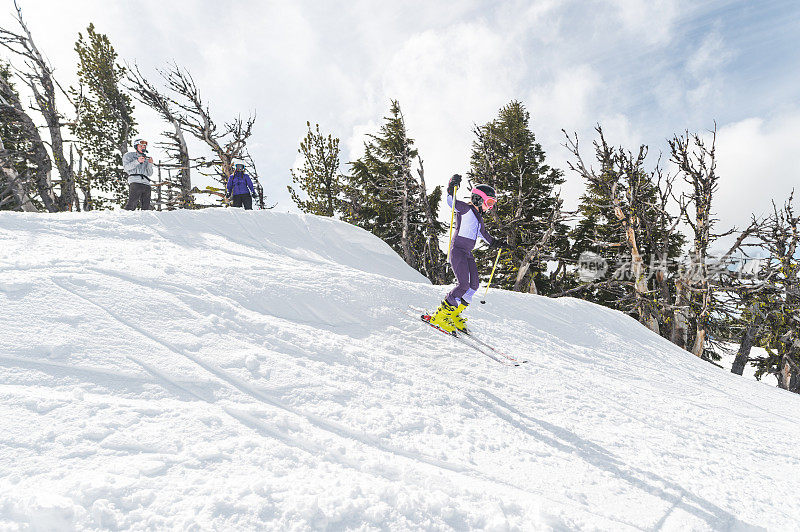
427;174;508;333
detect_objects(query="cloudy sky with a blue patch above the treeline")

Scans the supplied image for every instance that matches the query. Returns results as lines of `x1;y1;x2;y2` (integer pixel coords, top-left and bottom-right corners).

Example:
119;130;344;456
0;0;800;231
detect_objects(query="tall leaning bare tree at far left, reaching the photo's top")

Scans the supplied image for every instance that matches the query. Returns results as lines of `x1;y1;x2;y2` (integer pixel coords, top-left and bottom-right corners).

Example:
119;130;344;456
0;0;75;212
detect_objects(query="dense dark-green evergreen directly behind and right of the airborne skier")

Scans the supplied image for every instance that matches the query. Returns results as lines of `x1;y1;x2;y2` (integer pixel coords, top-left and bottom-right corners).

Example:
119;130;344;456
470;101;569;294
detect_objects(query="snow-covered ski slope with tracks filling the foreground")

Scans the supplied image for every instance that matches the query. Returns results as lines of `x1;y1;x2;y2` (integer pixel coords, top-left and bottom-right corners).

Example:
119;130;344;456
0;209;800;530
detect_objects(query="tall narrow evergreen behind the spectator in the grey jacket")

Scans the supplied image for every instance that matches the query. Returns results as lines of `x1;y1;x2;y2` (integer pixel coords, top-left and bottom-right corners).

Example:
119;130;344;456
71;24;136;208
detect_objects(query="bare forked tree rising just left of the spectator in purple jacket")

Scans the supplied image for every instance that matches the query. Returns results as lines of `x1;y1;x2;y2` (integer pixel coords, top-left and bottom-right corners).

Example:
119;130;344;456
159;64;256;182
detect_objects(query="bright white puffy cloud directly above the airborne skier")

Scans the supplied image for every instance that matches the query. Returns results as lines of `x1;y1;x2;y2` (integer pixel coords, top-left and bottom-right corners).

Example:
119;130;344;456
347;22;523;190
